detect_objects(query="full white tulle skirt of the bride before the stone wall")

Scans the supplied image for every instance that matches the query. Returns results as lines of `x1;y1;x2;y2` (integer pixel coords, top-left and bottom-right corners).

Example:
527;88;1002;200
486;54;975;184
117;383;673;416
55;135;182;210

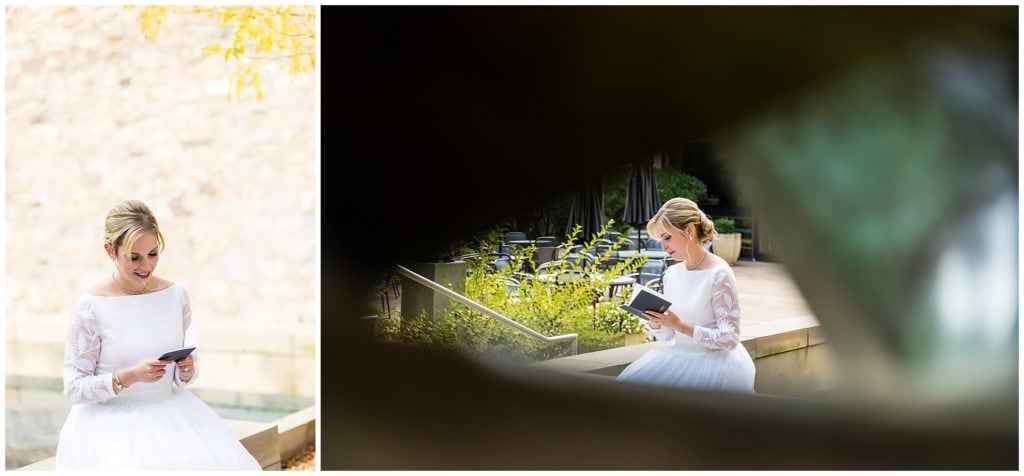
56;387;261;471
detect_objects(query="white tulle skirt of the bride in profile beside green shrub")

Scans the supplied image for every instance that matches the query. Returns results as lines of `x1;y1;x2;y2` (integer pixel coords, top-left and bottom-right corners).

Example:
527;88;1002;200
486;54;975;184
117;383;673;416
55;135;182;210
616;337;756;393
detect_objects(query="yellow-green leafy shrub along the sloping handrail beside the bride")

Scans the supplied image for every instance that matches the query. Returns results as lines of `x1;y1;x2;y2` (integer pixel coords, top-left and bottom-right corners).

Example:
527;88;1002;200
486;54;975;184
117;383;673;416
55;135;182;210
379;221;647;361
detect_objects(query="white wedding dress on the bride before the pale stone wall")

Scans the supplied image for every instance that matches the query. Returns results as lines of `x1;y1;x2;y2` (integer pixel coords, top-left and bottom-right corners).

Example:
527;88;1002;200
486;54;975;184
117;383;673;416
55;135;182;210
56;285;261;471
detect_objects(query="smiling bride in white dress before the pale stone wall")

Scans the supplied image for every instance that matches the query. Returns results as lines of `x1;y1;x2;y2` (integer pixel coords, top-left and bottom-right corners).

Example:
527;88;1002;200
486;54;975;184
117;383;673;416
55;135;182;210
56;201;261;471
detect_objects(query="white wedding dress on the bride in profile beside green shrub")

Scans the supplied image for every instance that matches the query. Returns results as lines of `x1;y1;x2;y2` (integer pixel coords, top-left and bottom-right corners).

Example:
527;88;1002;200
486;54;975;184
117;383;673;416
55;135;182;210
617;264;755;393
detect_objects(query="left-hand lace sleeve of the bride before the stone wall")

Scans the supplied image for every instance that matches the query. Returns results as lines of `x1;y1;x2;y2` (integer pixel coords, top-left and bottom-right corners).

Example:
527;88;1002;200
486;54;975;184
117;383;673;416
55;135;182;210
63;300;115;403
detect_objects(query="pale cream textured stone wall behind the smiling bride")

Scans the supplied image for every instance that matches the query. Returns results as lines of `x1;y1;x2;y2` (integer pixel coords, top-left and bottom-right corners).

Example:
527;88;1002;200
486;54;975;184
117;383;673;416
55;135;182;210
4;6;319;395
